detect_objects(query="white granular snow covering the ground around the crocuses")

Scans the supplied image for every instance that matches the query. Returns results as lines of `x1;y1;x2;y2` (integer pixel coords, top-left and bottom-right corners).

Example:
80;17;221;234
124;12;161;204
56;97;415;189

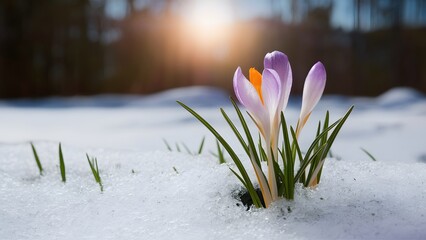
0;87;426;240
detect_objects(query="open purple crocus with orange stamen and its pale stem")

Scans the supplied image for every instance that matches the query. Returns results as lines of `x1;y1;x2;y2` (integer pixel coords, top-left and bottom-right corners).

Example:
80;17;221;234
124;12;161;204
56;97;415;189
233;51;292;204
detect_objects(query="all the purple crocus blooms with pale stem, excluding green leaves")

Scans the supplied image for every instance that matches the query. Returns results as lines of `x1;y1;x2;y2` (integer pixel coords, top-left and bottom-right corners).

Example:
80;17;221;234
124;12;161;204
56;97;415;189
233;51;326;204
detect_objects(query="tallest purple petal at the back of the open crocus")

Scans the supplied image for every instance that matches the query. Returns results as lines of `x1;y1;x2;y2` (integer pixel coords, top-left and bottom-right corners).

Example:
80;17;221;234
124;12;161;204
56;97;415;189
263;51;293;111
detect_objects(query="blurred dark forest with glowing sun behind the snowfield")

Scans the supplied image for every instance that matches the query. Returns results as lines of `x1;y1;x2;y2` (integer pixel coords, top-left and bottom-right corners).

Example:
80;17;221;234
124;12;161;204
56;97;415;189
0;0;426;98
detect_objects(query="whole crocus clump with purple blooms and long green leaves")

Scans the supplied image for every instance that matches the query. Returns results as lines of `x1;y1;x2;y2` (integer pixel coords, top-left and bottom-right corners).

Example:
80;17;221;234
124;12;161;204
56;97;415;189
178;51;353;207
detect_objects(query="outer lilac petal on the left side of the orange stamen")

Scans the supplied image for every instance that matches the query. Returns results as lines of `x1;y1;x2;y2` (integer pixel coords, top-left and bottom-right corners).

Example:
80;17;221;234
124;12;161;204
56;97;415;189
233;67;269;136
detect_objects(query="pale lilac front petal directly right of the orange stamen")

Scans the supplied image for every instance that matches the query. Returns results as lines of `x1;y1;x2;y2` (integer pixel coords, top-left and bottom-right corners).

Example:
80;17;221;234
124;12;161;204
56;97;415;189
262;68;282;119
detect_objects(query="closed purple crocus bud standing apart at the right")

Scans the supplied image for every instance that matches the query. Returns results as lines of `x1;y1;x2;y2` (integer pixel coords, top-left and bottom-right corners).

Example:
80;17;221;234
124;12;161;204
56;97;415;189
300;62;327;121
